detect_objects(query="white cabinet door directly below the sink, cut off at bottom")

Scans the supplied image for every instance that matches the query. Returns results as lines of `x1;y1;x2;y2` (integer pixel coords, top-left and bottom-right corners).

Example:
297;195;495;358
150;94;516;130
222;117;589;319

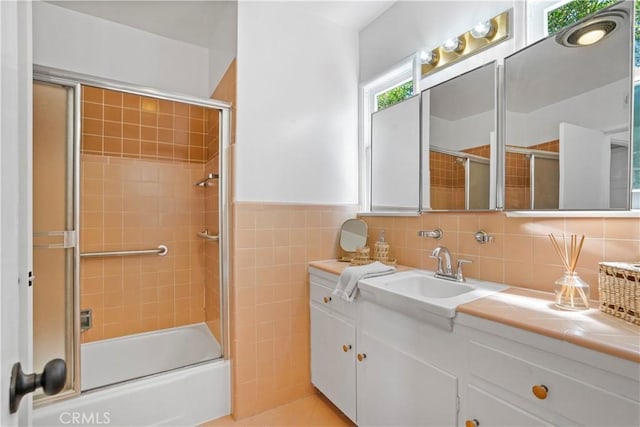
357;333;458;426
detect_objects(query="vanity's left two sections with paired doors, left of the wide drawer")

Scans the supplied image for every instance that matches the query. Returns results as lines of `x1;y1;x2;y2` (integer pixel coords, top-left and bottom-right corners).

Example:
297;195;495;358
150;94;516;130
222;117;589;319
309;268;458;426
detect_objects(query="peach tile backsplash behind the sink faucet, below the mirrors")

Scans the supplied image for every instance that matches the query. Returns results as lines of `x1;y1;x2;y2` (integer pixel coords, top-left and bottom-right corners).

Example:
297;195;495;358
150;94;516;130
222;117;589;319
363;213;640;299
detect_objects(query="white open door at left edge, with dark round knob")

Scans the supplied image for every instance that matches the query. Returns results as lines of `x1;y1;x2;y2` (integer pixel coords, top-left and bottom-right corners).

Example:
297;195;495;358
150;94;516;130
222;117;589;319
0;1;32;427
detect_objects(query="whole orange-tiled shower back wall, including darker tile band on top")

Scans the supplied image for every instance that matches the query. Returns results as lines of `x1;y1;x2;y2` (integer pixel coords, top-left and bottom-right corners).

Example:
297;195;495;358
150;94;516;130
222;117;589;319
80;87;219;342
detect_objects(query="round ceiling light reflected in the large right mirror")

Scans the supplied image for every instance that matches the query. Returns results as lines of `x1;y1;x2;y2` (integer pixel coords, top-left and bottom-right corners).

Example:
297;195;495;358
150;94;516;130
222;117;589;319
556;11;625;47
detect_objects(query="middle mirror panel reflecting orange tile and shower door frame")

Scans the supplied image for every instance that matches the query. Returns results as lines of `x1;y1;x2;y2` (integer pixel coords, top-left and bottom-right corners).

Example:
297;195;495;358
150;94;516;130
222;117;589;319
421;61;497;210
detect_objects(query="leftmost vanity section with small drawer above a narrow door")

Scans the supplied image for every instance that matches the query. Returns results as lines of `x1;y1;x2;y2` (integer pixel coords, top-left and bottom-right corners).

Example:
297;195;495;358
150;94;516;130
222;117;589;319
309;269;356;422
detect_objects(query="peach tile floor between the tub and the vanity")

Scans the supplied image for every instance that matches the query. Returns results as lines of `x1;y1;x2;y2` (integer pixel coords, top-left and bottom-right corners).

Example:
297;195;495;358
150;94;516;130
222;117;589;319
201;394;355;427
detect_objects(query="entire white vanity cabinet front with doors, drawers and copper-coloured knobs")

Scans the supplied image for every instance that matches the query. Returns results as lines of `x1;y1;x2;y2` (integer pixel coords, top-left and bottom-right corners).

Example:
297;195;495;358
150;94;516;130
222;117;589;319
310;268;640;427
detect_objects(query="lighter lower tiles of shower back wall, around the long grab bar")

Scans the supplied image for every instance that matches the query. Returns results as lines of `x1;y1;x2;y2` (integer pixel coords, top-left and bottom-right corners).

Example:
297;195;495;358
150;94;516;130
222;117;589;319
80;154;211;342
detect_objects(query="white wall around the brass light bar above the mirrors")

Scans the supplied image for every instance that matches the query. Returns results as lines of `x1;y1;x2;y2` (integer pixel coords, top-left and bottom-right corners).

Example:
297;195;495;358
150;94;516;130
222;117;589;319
360;0;525;89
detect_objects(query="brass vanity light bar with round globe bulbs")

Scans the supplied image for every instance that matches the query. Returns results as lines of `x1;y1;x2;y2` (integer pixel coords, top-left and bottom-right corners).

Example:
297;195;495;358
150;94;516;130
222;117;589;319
419;10;510;77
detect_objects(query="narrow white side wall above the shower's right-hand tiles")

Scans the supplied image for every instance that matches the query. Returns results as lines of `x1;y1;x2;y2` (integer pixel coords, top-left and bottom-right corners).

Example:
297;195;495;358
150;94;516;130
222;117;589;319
207;1;238;94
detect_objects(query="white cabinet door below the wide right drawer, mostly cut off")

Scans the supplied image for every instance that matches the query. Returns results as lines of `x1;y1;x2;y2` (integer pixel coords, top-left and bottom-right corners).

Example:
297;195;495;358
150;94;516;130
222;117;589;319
464;384;551;427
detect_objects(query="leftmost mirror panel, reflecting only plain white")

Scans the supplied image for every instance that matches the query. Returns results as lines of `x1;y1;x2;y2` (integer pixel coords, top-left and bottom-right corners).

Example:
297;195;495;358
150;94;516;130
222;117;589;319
370;96;420;212
